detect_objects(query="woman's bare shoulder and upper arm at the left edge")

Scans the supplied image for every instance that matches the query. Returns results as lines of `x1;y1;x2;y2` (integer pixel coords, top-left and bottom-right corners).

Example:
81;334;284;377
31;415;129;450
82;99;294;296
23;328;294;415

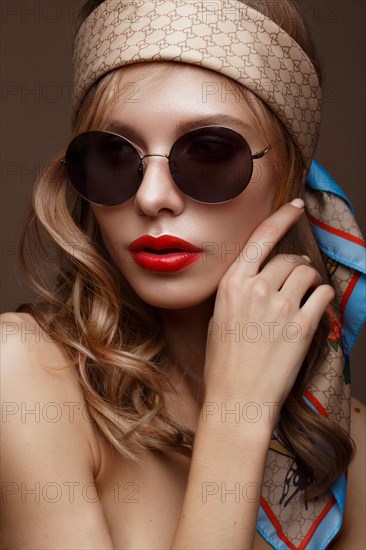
0;313;112;550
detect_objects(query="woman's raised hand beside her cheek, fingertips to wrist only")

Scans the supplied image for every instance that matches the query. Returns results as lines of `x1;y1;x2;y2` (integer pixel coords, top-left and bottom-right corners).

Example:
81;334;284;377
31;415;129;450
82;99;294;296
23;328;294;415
204;201;334;414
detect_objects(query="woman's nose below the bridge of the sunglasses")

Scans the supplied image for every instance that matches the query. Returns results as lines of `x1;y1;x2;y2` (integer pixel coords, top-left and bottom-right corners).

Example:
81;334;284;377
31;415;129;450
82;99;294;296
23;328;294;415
134;155;185;217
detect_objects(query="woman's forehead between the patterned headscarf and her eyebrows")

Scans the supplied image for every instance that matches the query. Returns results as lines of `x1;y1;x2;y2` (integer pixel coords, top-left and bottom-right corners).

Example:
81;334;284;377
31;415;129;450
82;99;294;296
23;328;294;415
104;61;262;136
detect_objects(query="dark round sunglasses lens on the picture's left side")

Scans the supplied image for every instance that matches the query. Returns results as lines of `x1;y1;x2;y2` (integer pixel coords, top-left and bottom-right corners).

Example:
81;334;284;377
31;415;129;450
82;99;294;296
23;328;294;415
65;132;141;206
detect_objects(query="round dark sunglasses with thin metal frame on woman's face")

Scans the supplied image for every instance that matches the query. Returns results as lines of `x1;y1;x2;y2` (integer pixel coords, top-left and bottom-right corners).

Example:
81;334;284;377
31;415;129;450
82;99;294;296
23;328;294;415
61;126;271;206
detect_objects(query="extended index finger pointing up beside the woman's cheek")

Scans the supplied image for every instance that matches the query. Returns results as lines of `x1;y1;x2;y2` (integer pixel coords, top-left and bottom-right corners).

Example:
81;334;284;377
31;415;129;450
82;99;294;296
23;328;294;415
232;199;304;277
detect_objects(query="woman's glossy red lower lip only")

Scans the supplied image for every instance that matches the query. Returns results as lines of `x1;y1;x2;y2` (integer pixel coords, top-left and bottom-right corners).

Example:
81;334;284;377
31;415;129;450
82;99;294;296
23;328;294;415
131;250;202;273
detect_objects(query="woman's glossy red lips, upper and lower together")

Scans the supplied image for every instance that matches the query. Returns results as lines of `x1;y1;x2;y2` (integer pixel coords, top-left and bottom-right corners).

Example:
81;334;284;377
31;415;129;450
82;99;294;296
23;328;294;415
128;235;203;273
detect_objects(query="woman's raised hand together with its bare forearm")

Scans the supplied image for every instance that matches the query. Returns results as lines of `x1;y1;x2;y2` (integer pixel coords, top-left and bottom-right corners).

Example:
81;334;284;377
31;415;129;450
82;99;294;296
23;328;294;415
172;203;328;548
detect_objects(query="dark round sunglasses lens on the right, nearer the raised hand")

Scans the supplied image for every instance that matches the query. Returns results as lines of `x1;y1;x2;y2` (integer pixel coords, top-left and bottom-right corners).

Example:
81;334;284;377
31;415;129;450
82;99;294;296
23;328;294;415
170;126;253;203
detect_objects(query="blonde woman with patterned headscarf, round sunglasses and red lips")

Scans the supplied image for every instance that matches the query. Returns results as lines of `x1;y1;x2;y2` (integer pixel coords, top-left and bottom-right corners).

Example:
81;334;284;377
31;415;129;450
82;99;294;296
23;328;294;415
2;0;362;549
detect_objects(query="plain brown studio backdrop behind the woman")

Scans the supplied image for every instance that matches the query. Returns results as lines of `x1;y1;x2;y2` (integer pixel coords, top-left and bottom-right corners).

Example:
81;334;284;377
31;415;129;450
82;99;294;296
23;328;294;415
1;0;366;401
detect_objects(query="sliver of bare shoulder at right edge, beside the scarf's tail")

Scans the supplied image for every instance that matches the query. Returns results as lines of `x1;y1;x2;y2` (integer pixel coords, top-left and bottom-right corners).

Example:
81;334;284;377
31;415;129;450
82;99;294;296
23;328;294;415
331;398;366;550
